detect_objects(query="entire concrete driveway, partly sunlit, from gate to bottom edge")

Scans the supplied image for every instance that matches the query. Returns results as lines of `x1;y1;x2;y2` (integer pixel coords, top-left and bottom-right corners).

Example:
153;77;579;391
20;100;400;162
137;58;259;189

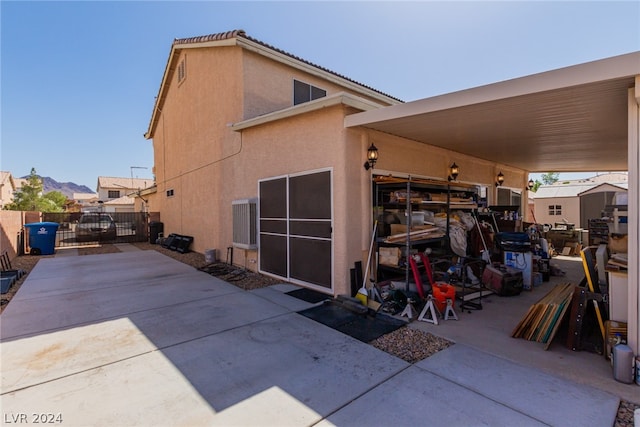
0;251;618;426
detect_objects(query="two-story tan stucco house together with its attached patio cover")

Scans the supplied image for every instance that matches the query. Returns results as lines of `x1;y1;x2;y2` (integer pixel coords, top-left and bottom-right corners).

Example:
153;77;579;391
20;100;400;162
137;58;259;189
141;30;640;356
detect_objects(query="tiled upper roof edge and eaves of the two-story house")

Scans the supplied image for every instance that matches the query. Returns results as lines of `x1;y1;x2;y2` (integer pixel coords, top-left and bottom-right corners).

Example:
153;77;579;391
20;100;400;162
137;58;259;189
145;30;403;139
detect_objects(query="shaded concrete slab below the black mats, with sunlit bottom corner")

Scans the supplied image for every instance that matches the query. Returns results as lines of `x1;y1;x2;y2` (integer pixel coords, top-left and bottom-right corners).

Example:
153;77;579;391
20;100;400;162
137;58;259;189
163;313;409;425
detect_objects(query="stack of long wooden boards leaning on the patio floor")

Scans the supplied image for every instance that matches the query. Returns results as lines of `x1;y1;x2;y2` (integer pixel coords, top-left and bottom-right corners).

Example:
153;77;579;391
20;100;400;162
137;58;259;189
511;283;575;350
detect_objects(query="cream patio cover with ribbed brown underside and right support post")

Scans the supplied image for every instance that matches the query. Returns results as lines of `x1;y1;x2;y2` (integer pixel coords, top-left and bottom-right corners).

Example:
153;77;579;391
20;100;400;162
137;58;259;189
345;52;640;354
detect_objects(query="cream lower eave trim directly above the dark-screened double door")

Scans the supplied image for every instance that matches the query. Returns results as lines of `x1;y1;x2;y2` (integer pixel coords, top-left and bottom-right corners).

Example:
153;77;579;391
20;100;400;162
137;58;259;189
230;92;382;131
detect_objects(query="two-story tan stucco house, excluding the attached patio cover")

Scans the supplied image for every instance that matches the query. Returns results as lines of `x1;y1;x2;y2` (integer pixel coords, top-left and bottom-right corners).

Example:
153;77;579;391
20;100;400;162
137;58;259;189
146;31;528;294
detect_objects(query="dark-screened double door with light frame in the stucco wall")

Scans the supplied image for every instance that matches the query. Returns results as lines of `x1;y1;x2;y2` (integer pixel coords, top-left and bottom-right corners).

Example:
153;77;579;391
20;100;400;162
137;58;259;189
259;170;333;289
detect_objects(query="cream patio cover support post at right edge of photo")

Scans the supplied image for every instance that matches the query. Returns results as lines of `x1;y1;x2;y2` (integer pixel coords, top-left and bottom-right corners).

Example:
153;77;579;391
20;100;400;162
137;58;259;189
627;83;640;354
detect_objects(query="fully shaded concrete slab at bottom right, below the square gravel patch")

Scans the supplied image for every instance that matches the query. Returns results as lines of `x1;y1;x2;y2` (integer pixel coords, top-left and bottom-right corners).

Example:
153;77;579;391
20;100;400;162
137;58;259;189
415;344;620;427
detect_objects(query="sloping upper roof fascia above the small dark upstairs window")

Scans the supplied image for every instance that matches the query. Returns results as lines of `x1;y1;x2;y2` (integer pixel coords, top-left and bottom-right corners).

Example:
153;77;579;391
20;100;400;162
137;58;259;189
237;37;402;105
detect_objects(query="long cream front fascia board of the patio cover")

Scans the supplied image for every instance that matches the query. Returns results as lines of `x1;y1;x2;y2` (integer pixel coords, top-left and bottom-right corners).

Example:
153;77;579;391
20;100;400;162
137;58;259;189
345;52;640;127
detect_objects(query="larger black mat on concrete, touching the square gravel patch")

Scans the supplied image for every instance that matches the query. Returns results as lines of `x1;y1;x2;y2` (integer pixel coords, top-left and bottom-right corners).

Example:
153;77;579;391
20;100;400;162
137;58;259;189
298;302;407;342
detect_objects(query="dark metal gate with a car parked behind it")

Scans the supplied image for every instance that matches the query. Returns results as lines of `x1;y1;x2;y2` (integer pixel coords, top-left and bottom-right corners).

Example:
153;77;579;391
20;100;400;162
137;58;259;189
42;212;149;247
